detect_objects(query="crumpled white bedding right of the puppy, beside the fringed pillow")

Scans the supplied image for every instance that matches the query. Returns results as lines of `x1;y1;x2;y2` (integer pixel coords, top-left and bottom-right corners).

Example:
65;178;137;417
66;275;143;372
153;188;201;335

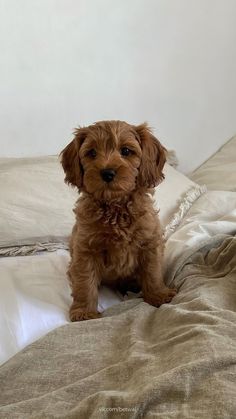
164;191;236;284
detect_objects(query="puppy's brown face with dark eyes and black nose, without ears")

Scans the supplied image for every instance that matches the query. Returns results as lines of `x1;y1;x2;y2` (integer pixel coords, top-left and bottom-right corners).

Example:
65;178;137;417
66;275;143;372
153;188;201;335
79;123;142;199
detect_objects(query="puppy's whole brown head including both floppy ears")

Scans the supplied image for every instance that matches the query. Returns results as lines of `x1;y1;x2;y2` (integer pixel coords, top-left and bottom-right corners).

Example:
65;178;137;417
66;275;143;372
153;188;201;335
61;121;165;200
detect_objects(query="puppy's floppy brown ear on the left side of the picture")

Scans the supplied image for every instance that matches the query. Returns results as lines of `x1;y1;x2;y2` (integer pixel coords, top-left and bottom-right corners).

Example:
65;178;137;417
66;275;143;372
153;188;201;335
60;128;87;188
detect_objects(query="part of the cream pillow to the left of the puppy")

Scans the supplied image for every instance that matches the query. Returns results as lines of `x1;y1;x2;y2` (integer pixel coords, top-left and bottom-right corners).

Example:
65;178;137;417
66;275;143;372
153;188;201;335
0;156;78;247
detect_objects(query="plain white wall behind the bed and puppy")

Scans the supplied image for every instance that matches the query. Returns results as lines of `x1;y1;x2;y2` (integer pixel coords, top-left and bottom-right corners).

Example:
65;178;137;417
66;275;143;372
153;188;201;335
0;0;236;171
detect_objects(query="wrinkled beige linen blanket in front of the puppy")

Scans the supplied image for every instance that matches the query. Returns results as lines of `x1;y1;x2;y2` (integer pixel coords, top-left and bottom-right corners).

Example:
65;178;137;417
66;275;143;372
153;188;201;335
0;235;236;419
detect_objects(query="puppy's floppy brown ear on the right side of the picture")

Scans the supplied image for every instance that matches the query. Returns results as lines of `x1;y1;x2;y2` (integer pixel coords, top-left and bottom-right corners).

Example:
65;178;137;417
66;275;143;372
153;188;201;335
134;123;166;188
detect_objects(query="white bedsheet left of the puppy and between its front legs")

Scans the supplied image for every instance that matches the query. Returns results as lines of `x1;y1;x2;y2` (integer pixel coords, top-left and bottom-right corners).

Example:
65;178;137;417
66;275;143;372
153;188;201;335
0;250;122;364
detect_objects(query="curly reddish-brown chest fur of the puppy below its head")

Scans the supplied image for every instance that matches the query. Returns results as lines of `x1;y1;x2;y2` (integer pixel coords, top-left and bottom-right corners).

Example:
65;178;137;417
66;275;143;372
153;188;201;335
74;196;158;282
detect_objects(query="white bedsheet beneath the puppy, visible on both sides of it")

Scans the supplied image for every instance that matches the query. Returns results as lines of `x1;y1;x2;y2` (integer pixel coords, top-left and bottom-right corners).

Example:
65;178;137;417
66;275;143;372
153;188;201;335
0;192;236;368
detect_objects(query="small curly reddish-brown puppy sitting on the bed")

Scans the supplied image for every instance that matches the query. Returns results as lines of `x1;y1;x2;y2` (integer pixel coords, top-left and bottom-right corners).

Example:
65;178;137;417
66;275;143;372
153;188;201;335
61;121;176;321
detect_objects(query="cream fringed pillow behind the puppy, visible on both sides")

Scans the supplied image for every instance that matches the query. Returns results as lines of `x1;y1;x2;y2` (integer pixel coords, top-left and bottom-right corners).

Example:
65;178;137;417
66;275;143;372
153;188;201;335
0;156;205;254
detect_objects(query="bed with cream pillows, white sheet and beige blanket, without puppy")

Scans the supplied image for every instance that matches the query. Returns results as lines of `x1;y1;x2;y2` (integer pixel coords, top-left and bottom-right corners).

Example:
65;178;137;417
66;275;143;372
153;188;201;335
0;137;236;419
